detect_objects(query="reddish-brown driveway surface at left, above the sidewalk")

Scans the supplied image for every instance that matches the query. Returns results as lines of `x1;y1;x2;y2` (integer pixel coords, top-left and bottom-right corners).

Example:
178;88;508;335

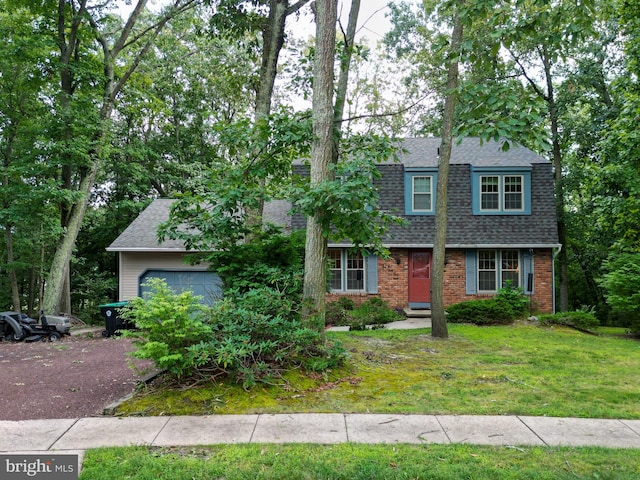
0;332;149;420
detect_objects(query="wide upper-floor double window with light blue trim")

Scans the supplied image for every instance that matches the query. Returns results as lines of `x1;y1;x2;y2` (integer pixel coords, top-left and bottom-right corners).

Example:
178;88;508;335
472;169;531;215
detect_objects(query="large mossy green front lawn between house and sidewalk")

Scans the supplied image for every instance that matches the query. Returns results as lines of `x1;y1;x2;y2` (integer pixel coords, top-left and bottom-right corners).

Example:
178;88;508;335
118;325;640;419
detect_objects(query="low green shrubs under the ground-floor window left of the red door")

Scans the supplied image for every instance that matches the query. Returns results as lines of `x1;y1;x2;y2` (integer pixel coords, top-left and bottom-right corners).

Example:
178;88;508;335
325;297;403;330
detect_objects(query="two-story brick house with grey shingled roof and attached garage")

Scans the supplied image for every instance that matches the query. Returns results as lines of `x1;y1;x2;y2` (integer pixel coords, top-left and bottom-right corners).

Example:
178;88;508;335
108;138;561;312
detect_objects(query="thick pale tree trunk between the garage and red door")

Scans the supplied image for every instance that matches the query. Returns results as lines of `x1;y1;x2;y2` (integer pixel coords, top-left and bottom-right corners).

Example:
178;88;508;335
303;0;338;331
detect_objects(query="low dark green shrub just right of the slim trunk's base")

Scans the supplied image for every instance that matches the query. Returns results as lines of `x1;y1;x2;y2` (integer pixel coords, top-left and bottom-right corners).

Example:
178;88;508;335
447;297;518;325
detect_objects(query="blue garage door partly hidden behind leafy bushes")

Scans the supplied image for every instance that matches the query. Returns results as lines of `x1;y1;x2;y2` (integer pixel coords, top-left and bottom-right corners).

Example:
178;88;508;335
139;270;222;305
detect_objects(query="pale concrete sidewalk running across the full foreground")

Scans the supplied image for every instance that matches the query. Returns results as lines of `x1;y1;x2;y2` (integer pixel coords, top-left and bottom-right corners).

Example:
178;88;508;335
0;413;640;453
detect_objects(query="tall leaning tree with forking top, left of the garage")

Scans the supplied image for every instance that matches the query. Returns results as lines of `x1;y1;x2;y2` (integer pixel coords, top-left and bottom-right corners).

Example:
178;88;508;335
42;0;193;312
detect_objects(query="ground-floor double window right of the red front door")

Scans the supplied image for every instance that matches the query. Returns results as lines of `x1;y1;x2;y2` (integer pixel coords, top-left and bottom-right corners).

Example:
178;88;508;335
477;250;520;292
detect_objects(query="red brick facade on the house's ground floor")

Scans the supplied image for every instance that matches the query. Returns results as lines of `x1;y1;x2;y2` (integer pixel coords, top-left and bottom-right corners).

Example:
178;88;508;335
327;249;553;313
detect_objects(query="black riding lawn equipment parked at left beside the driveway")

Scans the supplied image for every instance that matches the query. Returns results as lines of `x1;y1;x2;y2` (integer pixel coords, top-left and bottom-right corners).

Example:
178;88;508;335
0;312;71;342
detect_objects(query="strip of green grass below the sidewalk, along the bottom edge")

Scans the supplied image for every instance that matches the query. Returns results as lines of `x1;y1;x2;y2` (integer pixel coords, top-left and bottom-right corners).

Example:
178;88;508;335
80;444;640;480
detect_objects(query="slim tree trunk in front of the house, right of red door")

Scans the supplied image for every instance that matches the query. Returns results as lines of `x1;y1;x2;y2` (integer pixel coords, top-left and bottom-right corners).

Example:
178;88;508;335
431;1;464;338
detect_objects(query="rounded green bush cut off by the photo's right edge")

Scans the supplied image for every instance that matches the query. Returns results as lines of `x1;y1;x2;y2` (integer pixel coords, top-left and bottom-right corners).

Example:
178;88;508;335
604;253;640;335
